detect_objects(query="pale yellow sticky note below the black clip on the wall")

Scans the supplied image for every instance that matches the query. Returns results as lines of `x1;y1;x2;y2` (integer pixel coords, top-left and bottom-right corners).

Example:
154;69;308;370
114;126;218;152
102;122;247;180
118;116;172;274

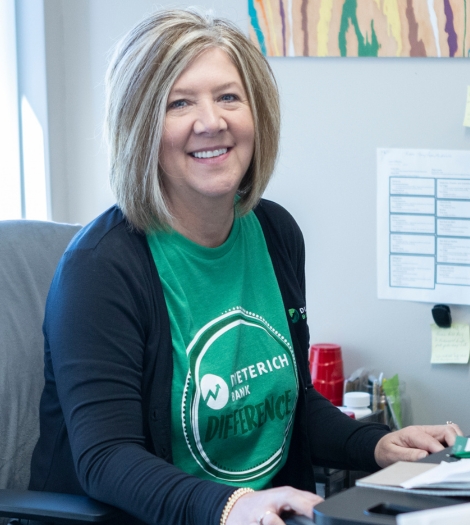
431;323;470;364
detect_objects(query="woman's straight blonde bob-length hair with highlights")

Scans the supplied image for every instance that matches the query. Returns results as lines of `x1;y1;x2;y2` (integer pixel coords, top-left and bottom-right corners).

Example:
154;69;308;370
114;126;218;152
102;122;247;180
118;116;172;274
105;9;280;231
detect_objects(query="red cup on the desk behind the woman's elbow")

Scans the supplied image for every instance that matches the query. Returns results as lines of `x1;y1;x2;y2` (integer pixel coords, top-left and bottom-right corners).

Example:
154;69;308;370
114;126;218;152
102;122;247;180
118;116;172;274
309;343;344;406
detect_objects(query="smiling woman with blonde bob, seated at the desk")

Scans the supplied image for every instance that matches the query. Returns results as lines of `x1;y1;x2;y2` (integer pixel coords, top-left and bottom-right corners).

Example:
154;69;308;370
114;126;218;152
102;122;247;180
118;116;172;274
30;11;460;525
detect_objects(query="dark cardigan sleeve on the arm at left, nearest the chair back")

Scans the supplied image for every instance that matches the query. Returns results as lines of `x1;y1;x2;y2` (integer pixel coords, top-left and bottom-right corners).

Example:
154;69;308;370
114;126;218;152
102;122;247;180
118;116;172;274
44;215;235;525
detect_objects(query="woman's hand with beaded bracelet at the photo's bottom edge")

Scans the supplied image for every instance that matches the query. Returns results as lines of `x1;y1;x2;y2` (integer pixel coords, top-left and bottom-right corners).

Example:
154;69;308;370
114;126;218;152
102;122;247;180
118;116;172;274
226;487;323;525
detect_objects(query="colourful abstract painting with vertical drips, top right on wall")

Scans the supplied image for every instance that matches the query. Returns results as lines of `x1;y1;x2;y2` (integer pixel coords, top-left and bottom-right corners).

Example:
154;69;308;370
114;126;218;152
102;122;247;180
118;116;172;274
248;0;470;58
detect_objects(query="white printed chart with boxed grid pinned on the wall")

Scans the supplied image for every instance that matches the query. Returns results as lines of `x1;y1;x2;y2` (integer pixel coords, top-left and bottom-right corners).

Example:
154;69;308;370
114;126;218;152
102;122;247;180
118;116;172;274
377;148;470;305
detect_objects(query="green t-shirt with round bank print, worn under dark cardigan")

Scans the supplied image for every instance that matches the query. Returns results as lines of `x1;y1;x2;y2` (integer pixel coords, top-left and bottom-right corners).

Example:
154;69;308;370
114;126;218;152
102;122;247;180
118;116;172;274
147;212;298;489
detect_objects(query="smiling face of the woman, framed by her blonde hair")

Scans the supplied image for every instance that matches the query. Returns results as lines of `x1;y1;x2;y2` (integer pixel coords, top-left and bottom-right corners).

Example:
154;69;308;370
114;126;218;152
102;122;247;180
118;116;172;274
160;48;254;212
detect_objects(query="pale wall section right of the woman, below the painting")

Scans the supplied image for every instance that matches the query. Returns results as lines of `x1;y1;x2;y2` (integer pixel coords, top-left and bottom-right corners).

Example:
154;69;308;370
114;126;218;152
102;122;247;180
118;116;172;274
267;58;470;432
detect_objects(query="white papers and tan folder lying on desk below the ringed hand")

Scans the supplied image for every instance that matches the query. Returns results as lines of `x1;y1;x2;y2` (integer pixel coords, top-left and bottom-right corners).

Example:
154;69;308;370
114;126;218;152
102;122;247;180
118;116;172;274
356;459;470;496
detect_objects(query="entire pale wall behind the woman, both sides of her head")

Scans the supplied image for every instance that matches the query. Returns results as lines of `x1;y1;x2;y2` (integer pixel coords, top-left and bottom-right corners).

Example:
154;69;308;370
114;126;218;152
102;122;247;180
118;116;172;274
45;0;470;433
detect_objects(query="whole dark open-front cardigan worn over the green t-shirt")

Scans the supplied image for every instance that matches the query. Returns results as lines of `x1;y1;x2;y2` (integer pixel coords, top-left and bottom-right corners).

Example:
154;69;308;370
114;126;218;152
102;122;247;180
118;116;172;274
30;200;388;525
